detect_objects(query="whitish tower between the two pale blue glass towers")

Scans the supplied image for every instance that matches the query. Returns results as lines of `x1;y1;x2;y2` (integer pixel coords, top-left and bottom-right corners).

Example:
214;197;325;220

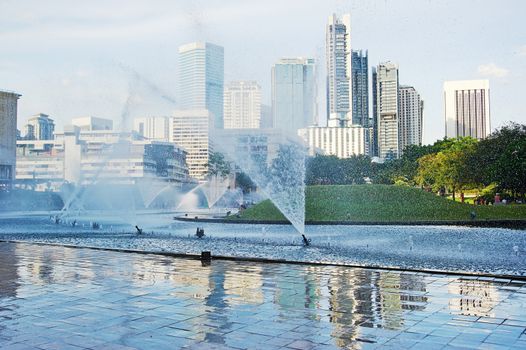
224;81;261;129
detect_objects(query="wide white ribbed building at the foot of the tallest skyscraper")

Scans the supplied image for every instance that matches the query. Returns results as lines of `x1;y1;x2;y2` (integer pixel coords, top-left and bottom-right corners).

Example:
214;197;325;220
298;125;371;158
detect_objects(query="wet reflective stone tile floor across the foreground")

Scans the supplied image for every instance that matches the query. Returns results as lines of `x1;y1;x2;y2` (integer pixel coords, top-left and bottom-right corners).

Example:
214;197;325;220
0;243;526;349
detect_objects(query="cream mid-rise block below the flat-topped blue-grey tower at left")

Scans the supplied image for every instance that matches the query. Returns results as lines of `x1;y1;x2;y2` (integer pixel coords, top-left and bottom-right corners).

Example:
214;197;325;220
170;109;214;180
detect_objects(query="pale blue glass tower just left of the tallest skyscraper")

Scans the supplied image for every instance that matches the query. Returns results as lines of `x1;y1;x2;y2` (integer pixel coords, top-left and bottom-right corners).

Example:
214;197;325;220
272;57;318;134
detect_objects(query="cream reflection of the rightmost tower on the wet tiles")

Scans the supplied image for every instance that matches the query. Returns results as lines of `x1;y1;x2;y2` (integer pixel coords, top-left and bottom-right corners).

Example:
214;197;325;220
448;280;499;317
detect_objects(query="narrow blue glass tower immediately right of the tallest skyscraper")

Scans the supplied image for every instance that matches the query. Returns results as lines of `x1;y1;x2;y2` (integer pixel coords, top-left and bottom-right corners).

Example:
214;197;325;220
351;50;369;128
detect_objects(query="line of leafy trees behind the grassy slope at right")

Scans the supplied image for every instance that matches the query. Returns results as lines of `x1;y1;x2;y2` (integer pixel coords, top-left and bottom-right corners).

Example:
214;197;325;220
306;123;526;200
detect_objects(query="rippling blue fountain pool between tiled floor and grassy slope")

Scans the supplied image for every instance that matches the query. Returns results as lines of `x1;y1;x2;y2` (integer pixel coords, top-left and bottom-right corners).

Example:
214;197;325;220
0;215;526;275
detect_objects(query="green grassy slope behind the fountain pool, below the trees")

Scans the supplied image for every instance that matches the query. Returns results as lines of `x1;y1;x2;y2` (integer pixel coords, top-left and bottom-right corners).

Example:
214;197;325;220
235;185;526;221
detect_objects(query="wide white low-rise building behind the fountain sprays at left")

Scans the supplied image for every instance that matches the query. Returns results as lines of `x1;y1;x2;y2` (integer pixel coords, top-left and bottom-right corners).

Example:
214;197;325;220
16;126;188;190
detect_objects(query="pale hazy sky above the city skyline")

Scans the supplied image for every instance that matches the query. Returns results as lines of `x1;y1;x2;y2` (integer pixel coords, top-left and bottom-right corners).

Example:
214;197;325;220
0;0;526;144
